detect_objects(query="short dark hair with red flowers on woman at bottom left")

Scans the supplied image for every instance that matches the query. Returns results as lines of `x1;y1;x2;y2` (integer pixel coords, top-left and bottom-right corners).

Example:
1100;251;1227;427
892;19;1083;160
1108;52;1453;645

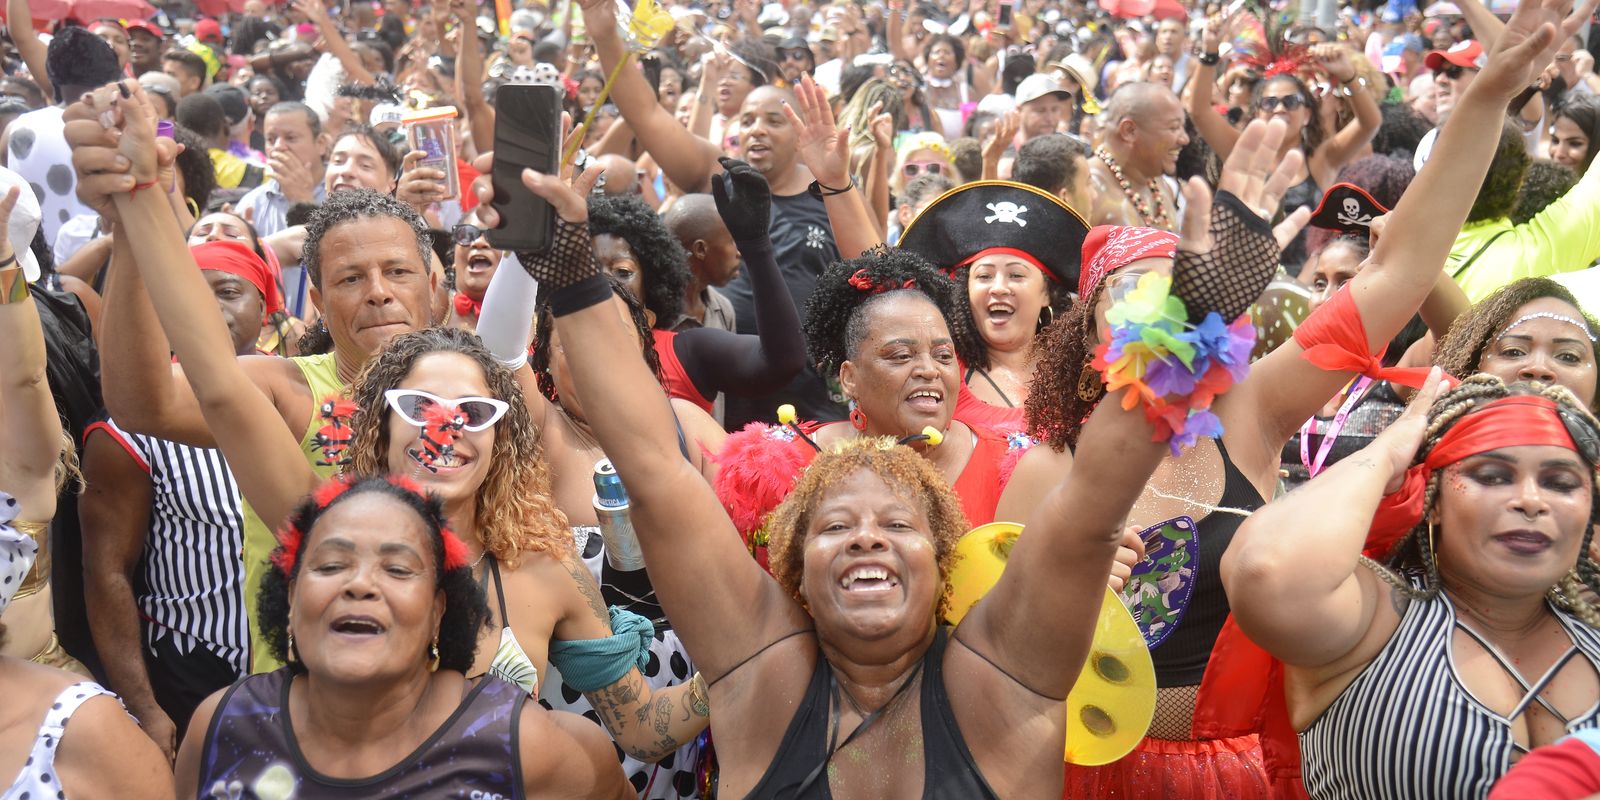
256;475;490;675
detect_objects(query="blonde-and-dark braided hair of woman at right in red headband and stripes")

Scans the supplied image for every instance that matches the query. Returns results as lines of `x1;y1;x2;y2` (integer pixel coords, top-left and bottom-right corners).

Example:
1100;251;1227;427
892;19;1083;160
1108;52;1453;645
1362;373;1600;627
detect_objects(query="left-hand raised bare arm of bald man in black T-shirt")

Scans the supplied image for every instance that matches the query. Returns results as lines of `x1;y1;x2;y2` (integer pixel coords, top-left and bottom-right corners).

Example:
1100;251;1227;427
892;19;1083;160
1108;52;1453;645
582;0;720;192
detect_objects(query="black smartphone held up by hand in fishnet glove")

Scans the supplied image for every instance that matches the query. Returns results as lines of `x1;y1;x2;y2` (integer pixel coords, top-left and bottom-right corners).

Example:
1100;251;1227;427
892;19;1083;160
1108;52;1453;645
488;85;562;253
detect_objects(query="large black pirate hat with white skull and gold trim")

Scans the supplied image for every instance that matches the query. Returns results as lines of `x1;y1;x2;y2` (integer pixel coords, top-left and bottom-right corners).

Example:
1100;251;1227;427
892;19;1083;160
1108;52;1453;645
899;181;1090;288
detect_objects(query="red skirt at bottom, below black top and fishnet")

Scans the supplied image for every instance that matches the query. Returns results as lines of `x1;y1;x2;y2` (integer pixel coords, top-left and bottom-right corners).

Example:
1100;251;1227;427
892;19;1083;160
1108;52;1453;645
1062;734;1272;800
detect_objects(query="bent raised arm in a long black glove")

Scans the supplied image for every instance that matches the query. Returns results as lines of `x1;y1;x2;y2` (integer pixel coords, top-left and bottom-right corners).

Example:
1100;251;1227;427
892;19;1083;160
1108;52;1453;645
674;158;805;397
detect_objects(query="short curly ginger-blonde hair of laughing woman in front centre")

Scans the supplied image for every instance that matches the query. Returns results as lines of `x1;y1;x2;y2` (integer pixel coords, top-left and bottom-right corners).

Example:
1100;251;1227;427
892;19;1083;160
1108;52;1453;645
766;437;968;619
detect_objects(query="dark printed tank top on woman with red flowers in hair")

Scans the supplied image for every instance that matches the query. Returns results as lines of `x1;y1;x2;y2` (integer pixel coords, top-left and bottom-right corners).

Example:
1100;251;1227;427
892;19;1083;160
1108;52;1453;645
198;667;528;800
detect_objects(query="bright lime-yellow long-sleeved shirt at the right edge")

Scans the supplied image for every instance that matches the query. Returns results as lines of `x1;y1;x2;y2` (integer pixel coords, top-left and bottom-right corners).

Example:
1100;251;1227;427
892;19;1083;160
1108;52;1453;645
1445;151;1600;302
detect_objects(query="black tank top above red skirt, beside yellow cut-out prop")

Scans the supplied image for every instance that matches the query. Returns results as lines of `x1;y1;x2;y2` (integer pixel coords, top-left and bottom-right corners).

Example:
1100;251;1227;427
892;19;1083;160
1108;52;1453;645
1150;438;1266;688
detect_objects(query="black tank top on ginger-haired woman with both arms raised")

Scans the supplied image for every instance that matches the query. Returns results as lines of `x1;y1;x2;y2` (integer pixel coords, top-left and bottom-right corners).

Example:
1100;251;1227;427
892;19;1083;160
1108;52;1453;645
749;626;998;800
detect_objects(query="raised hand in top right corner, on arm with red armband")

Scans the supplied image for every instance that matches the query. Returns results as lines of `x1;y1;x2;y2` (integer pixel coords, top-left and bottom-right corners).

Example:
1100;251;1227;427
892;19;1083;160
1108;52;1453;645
1467;0;1600;99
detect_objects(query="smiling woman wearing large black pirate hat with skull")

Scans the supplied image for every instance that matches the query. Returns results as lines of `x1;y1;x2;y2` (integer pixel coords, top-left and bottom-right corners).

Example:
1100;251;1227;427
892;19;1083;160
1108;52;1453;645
899;181;1088;435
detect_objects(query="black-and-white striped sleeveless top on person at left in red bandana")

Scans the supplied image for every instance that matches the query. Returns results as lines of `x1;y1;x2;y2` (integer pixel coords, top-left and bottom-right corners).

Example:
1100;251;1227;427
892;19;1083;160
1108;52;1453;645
85;421;250;675
